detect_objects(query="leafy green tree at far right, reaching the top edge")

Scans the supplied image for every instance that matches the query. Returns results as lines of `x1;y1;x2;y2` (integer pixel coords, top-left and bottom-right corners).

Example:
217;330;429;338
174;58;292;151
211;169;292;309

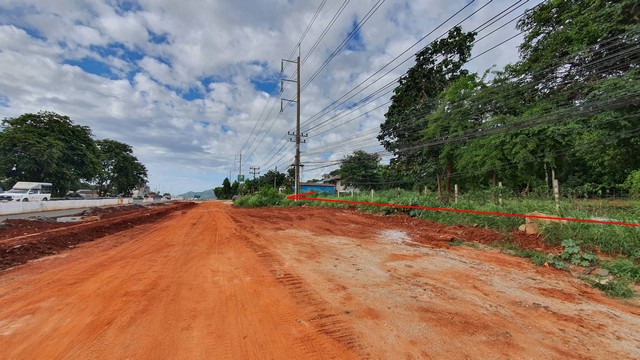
503;0;640;193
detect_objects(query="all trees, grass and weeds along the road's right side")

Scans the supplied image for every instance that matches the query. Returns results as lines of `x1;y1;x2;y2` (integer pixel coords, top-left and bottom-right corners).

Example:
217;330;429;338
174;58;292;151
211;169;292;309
228;0;640;296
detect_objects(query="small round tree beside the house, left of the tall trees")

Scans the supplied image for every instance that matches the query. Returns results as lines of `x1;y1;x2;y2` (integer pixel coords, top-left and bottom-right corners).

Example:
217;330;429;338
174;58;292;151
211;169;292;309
340;150;380;190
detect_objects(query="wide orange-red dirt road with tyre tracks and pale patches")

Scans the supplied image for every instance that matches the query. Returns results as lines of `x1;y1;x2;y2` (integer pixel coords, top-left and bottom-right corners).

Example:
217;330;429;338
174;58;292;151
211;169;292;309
0;202;640;359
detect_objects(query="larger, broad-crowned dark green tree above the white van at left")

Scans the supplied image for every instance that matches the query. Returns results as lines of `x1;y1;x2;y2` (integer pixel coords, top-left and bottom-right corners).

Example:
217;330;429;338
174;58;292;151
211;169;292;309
0;111;100;196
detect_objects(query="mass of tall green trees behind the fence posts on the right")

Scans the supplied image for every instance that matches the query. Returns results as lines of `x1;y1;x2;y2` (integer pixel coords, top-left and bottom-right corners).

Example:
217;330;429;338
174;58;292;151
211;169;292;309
379;0;640;200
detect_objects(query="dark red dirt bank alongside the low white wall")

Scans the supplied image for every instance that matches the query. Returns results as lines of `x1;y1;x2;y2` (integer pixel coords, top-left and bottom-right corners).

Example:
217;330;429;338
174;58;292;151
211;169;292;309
0;202;195;270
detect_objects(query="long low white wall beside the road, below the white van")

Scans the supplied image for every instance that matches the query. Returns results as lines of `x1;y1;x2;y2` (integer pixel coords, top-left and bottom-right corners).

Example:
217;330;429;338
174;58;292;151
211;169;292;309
0;198;133;215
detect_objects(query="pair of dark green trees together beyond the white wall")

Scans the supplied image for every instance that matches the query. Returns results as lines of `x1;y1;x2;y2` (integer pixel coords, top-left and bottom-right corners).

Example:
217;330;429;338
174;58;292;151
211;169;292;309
0;111;147;196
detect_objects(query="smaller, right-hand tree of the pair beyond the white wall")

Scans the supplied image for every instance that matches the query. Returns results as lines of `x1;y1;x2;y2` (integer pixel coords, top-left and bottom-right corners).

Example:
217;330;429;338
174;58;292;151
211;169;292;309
96;139;147;196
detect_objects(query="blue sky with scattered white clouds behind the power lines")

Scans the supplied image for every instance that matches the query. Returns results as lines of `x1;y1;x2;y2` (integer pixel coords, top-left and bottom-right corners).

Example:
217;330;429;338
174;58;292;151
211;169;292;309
0;0;539;194
